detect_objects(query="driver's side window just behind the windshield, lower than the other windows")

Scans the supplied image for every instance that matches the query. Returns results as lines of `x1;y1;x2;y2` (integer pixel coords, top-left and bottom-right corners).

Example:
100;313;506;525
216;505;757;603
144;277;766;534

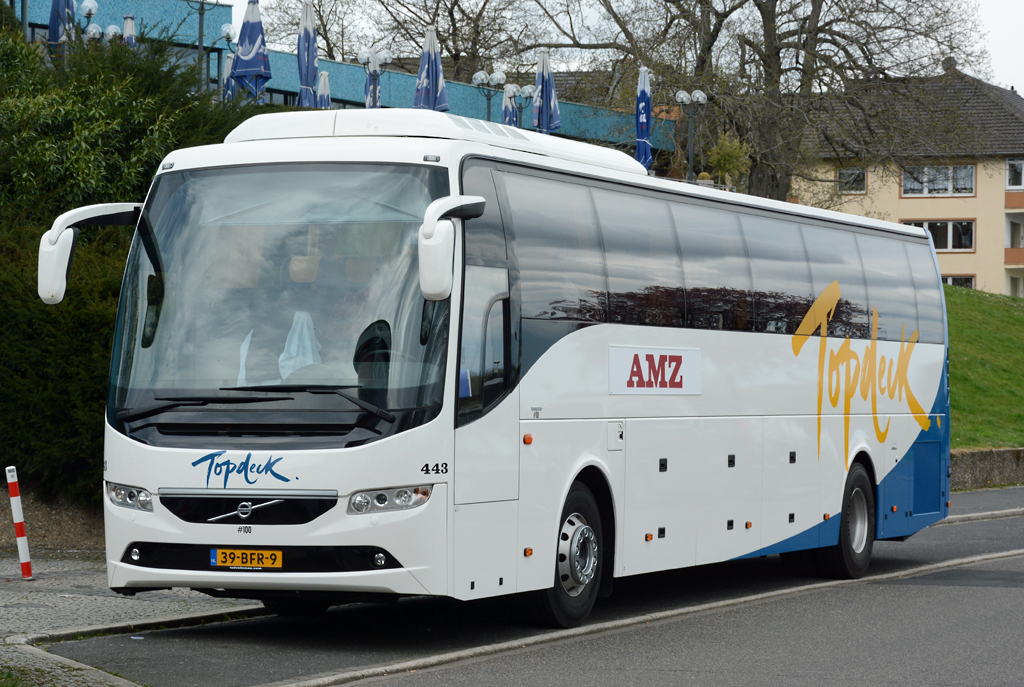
458;265;509;427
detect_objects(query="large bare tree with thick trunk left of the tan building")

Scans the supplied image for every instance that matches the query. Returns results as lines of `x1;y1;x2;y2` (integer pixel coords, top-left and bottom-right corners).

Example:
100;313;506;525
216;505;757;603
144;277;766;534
519;0;986;200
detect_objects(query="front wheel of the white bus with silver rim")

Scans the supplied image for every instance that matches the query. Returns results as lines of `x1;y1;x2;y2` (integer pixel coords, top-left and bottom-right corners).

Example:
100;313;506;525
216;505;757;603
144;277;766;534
535;482;604;628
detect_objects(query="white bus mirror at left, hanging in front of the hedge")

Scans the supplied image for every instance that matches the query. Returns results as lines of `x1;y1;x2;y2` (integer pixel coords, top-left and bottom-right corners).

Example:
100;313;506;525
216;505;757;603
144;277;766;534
37;203;142;305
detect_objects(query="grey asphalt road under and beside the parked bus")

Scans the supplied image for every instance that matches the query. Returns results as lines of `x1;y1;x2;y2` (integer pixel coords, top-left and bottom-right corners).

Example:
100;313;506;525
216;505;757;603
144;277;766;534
50;489;1024;687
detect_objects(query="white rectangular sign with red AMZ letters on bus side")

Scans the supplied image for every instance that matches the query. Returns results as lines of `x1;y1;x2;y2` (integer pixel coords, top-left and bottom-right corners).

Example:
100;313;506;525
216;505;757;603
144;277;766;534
608;346;700;395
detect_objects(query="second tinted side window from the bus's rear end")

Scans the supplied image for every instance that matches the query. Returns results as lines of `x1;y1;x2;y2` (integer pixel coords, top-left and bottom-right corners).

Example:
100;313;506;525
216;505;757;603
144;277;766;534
857;235;918;341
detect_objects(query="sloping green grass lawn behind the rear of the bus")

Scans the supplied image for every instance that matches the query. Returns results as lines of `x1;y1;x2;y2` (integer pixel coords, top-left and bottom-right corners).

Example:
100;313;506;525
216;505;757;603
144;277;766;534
945;287;1024;448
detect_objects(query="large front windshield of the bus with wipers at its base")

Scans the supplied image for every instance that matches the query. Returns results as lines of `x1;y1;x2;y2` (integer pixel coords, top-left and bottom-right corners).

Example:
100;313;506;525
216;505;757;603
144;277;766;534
109;163;449;445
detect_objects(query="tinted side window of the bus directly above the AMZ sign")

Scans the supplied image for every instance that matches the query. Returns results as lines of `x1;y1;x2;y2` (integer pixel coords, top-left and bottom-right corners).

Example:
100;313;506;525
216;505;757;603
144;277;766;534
593;188;685;327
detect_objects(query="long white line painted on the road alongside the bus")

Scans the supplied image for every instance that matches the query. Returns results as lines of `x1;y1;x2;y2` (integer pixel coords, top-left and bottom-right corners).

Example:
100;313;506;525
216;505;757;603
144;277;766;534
263;549;1024;687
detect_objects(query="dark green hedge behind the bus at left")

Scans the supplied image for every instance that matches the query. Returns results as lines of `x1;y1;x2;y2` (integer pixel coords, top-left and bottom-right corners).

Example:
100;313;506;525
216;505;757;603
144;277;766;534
0;22;288;504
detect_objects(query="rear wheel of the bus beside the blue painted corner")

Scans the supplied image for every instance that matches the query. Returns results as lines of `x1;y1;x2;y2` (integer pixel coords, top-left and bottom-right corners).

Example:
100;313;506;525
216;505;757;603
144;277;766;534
818;463;874;579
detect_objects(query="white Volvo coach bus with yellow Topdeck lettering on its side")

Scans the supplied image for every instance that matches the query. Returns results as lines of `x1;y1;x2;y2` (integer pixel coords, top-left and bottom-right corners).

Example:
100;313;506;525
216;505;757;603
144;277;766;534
39;110;949;627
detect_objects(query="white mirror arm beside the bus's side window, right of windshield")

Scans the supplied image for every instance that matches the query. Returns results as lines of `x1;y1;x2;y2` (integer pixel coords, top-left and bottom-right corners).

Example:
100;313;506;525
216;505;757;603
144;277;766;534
419;196;486;301
